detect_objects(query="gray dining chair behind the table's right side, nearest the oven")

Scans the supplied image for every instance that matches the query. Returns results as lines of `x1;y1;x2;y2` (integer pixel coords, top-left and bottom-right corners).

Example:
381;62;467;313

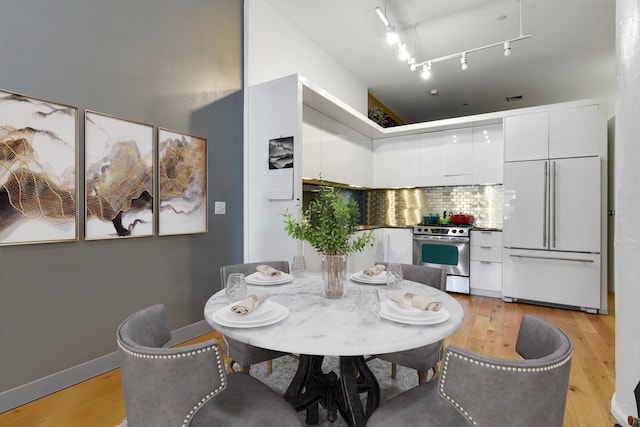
376;262;447;384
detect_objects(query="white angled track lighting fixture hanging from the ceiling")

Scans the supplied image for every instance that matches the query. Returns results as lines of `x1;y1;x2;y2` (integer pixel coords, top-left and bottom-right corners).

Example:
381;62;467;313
375;0;531;79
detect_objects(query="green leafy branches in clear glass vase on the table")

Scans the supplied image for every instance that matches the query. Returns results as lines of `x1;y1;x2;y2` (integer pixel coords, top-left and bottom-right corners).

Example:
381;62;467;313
282;186;374;298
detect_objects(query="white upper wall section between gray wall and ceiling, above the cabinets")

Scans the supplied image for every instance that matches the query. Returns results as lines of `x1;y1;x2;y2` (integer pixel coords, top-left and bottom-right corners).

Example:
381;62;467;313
245;0;367;115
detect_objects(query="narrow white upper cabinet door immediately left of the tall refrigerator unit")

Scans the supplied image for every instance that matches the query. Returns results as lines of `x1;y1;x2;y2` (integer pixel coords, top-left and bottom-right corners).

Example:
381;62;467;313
473;124;504;185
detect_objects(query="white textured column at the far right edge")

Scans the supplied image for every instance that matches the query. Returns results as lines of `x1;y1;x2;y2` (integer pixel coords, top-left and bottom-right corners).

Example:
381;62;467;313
611;0;640;425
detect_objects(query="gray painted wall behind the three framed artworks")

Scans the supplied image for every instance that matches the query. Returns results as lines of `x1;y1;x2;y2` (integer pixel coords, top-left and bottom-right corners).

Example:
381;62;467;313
0;0;243;393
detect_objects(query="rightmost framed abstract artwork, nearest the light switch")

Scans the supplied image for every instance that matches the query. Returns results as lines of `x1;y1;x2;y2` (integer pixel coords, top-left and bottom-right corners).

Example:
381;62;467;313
158;128;207;236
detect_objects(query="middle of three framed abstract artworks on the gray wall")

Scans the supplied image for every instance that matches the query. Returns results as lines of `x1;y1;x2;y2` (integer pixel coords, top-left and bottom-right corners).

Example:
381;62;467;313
84;111;155;240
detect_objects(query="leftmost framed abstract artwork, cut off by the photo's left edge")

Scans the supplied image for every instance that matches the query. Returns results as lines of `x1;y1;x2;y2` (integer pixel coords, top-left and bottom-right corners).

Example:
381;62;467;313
0;90;78;245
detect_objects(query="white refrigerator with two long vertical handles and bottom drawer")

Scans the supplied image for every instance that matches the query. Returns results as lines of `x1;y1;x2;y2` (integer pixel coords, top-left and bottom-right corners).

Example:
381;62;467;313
503;157;602;312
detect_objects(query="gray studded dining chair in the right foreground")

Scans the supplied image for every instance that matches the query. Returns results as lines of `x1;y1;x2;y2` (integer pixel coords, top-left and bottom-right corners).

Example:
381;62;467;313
367;315;573;427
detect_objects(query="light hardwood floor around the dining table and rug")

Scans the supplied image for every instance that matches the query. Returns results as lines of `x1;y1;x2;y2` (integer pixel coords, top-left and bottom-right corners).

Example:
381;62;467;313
0;295;615;427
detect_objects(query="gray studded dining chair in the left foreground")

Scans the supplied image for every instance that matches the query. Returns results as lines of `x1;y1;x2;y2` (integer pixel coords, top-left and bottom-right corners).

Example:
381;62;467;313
117;304;302;427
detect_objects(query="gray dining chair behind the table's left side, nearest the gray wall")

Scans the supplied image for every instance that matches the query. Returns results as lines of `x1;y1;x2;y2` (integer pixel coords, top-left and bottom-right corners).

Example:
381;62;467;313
220;261;289;374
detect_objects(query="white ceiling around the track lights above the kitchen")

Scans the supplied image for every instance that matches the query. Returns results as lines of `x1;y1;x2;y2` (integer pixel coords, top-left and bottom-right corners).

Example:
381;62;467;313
266;0;616;123
